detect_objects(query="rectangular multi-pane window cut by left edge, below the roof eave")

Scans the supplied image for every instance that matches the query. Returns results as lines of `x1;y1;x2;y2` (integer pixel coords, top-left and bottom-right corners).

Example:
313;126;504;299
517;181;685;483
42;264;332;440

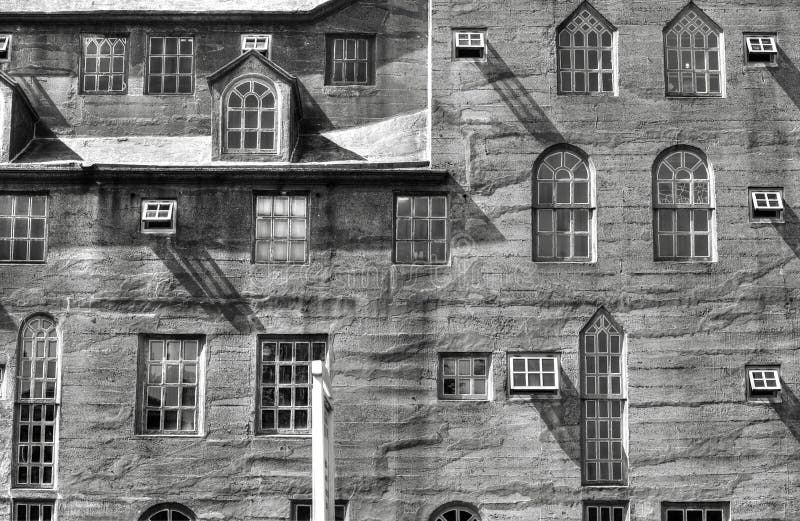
0;194;47;262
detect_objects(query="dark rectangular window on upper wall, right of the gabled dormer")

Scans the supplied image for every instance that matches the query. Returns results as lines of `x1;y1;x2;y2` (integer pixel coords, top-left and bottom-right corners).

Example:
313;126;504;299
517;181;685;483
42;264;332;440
325;34;375;85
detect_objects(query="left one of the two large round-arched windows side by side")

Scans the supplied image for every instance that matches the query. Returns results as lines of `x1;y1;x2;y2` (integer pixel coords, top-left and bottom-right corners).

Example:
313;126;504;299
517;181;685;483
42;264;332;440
533;146;595;261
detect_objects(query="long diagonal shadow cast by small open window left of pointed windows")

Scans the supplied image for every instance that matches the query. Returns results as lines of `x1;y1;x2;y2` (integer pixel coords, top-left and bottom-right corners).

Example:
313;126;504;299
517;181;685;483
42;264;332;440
476;44;566;143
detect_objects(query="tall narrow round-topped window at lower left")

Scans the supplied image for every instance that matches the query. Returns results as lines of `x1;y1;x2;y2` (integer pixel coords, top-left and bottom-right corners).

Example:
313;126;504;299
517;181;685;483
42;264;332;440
13;315;59;488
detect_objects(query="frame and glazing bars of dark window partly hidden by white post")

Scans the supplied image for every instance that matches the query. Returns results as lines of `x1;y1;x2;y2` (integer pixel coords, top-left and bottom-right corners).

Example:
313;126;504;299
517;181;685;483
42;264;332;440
253;334;332;437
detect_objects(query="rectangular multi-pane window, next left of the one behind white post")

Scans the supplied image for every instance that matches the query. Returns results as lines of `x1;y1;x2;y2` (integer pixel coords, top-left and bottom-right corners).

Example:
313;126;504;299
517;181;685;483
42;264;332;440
140;337;202;434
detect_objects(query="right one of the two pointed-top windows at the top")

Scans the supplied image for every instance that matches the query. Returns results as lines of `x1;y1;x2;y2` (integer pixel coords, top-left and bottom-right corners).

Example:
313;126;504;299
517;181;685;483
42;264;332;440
664;4;725;96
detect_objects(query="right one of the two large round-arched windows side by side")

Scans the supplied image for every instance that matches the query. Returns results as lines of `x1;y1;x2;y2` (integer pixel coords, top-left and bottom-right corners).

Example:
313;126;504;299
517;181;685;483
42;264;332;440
653;148;714;260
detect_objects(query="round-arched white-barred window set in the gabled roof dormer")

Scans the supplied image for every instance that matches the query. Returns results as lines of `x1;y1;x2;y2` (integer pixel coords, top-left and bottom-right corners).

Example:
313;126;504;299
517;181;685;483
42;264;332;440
225;79;278;153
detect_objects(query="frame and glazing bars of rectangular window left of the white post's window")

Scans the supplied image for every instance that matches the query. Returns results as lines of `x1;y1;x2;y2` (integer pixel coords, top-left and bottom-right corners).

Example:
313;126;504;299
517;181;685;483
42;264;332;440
135;334;208;438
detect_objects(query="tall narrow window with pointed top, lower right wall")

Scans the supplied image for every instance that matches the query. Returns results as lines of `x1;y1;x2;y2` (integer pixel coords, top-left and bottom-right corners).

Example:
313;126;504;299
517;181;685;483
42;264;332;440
581;311;627;484
